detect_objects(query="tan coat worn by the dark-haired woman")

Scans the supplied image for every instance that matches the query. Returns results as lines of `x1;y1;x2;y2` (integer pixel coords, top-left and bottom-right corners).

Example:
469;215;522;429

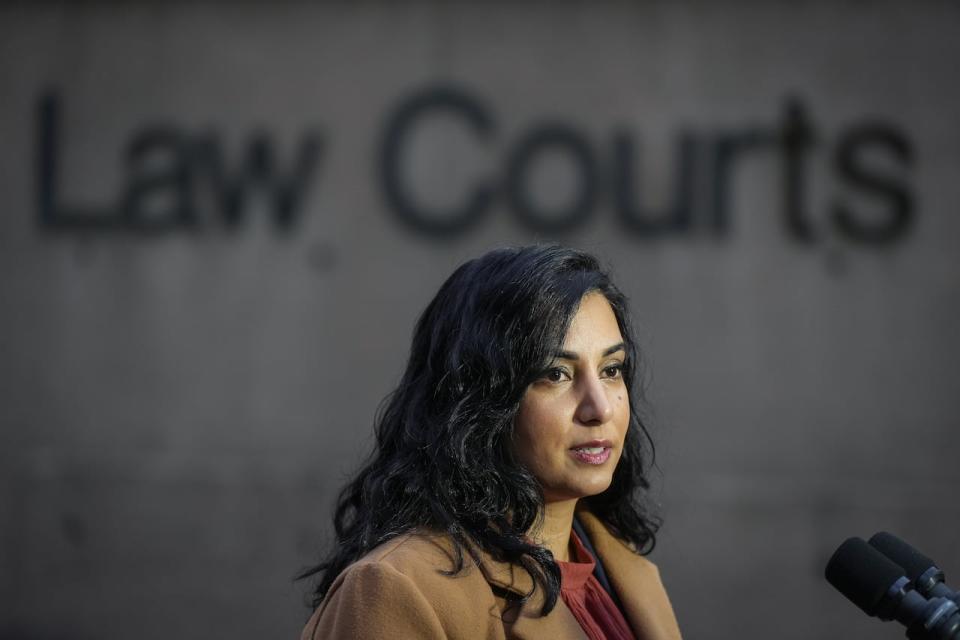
301;512;680;640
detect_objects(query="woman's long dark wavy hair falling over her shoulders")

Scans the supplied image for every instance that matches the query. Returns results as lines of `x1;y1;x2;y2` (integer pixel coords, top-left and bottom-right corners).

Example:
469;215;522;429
299;245;659;615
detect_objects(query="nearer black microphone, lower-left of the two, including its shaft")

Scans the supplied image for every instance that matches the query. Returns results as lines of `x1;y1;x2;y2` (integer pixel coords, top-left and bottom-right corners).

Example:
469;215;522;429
825;538;960;640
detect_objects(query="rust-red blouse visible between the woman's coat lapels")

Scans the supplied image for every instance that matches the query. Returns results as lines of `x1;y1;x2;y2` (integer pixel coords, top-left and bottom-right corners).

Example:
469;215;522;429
557;532;634;640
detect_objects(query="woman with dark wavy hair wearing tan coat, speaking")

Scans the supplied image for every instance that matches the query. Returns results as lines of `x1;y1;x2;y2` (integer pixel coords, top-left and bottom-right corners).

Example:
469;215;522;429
302;246;680;640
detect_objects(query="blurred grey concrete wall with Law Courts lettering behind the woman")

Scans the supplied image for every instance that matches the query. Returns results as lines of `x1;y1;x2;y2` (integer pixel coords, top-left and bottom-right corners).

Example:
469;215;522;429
0;0;960;640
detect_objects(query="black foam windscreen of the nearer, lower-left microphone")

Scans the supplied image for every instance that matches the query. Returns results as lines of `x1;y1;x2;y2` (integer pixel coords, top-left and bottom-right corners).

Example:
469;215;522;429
825;538;904;616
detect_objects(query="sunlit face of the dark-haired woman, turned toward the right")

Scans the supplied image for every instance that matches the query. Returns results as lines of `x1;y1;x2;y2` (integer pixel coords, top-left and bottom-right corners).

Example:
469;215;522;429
513;292;630;502
